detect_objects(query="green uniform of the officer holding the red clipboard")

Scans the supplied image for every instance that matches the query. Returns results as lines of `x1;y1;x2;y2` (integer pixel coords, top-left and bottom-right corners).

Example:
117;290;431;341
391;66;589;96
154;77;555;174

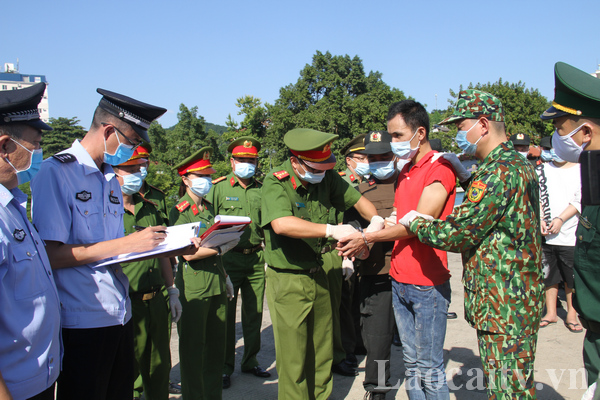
169;194;227;400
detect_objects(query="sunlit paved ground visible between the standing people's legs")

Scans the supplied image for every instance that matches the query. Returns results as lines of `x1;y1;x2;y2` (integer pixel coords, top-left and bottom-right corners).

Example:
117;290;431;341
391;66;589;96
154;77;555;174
166;253;585;400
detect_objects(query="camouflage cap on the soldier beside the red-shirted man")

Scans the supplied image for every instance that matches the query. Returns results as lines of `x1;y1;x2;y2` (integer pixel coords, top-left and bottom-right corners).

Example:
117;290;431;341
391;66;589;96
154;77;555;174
439;89;504;125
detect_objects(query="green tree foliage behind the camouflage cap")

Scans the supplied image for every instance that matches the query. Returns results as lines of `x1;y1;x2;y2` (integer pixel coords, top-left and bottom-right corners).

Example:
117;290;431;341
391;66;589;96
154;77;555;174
446;78;554;144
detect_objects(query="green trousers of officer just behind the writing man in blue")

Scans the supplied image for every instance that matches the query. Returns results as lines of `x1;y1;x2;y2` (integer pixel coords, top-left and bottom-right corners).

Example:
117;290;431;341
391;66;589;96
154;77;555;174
131;292;171;400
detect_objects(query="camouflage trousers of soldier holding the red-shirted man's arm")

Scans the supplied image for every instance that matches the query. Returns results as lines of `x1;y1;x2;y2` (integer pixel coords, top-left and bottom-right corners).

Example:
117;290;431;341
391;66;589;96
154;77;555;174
477;331;538;400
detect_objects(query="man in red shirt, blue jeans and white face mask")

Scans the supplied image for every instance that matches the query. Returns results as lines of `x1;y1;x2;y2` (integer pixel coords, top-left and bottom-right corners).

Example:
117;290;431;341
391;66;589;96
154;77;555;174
338;100;456;399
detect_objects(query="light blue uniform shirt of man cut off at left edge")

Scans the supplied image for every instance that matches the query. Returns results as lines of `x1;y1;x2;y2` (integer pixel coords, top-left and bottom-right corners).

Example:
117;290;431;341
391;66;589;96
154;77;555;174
0;185;62;399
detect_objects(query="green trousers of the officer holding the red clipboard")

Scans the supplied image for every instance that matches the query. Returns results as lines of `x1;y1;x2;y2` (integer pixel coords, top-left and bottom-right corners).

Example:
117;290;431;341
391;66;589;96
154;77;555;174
177;292;227;400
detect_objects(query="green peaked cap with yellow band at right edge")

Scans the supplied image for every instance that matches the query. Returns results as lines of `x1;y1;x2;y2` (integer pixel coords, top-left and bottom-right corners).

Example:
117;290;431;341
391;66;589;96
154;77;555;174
540;62;600;120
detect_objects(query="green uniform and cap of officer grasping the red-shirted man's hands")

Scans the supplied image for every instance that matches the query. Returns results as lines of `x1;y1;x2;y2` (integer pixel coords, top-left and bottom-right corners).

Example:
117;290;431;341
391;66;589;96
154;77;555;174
262;130;360;400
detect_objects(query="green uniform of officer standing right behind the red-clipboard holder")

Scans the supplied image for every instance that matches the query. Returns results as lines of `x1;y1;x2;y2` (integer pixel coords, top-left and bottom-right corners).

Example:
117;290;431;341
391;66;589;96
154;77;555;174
208;172;265;375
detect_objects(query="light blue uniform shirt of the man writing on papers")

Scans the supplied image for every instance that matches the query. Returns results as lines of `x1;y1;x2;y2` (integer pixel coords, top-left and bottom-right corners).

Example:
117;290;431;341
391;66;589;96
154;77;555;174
31;141;131;329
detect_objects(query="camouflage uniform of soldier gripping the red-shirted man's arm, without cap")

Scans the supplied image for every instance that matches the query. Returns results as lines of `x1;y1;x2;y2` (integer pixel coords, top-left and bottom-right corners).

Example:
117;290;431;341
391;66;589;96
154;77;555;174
410;142;543;399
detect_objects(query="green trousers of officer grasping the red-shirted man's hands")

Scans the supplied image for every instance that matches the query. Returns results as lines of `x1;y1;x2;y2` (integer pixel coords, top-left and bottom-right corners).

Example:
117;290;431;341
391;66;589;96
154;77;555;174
266;268;333;400
